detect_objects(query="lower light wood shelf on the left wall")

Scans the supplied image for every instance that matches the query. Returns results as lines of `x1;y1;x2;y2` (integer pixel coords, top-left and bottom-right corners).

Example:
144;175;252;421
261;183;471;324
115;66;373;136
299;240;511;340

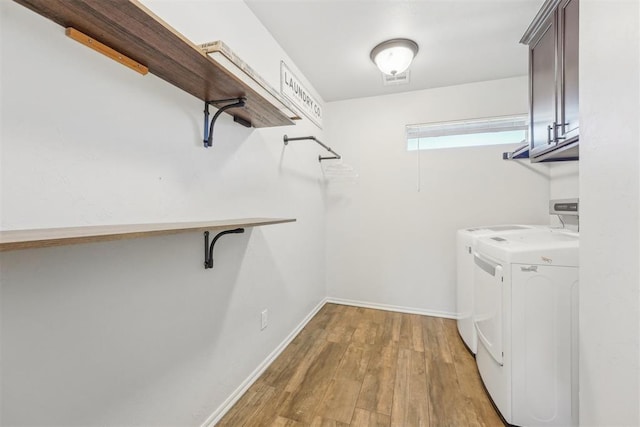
0;218;295;252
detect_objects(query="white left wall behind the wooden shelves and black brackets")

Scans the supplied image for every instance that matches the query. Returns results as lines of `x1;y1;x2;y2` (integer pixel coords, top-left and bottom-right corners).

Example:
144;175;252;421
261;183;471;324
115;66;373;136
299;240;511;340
0;0;326;426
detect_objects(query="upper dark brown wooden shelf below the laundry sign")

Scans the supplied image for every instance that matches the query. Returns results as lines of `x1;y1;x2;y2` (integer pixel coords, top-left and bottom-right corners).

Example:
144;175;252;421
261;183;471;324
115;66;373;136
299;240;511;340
15;0;299;128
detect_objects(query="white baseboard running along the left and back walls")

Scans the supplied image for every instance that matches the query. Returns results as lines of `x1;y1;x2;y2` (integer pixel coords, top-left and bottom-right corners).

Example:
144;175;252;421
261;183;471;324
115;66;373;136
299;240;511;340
201;298;456;427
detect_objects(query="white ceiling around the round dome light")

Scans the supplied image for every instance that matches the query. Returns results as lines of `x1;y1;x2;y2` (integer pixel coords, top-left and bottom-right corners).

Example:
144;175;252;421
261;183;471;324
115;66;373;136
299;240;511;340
245;0;543;101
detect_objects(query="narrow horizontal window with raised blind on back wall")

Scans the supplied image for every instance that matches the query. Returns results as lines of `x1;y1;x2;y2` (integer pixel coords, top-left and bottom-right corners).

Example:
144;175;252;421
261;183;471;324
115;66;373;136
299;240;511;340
407;115;528;151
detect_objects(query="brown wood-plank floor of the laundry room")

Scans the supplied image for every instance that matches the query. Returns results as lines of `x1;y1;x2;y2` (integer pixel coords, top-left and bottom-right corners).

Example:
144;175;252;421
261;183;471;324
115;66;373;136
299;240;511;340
217;304;503;427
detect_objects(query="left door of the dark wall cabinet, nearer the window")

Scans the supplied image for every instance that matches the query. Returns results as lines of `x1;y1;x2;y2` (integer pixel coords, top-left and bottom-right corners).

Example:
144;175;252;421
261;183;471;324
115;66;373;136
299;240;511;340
529;16;556;156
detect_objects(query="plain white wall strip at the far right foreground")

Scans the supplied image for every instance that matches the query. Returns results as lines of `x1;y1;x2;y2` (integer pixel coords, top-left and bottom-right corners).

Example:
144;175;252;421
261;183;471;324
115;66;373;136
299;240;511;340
580;0;640;426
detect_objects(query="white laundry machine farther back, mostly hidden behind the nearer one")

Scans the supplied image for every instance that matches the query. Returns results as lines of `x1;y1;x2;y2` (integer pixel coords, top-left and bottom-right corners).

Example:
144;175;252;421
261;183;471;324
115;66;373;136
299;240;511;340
456;224;549;354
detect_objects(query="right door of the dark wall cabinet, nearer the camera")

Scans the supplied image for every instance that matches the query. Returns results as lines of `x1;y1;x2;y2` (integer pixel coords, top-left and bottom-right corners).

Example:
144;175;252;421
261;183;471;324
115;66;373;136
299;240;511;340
558;0;579;142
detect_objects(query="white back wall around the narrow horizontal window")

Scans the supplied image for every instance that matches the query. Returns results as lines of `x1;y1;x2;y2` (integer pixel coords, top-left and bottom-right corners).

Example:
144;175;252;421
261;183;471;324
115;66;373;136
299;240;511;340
326;77;549;316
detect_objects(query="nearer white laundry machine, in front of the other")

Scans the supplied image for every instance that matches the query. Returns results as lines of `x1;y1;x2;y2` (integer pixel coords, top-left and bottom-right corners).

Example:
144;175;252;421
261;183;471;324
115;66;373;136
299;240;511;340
474;230;579;427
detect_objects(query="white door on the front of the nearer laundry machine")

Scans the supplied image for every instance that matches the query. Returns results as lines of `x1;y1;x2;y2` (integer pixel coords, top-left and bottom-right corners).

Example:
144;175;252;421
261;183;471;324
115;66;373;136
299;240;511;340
473;253;503;365
